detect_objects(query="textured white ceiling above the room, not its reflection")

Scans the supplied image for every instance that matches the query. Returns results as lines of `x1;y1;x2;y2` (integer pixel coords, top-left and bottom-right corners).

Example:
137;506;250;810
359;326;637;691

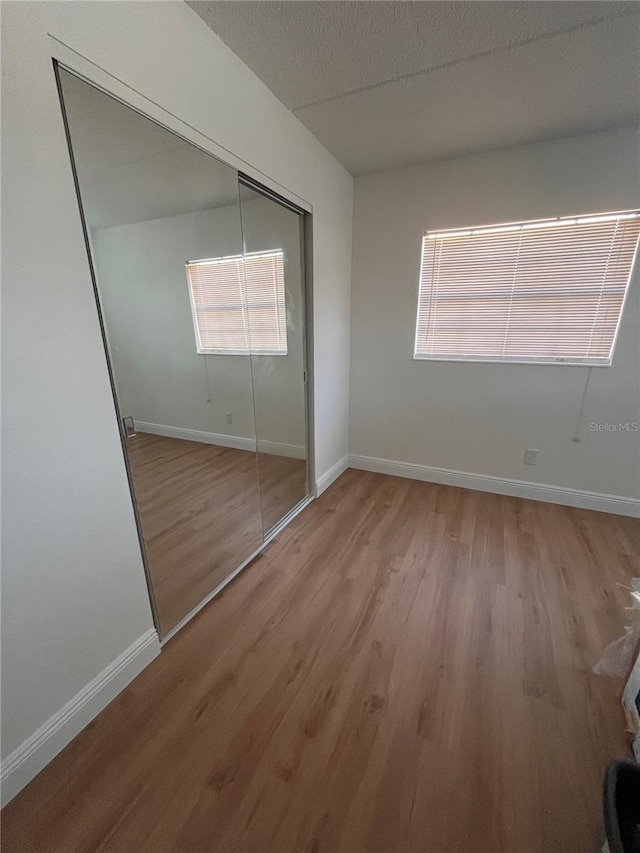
187;0;640;175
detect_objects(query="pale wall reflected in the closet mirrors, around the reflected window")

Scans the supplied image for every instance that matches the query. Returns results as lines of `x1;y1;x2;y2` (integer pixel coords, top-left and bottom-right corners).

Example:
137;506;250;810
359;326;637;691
92;198;305;456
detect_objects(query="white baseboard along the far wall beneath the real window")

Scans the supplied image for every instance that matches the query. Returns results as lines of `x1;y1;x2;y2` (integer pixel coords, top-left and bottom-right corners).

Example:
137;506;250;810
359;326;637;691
349;455;640;518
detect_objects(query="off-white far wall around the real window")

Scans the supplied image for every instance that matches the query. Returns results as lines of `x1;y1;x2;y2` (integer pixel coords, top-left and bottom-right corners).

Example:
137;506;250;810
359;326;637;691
350;129;640;498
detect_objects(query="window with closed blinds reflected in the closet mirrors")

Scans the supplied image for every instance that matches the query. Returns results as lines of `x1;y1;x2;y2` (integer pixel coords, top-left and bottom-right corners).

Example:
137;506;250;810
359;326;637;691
186;249;287;355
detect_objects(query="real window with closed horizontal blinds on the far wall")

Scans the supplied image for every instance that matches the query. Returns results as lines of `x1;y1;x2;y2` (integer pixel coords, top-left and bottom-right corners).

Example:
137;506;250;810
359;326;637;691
414;211;640;365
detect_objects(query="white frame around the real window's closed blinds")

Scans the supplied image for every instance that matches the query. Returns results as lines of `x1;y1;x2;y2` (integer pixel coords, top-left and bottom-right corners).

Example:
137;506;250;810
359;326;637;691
412;208;640;367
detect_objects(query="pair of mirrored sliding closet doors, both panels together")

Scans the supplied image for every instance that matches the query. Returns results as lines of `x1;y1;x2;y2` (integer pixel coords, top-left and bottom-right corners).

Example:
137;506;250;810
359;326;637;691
57;67;309;636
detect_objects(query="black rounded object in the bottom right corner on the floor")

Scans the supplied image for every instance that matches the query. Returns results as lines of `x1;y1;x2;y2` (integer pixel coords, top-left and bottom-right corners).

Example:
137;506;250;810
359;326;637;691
602;761;640;853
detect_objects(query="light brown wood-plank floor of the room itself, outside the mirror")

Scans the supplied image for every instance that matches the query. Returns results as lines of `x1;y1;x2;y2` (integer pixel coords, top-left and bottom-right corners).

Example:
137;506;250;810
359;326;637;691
2;470;640;853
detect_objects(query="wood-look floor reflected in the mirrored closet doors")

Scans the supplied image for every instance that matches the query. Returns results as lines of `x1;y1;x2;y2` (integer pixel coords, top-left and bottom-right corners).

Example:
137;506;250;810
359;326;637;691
127;433;306;634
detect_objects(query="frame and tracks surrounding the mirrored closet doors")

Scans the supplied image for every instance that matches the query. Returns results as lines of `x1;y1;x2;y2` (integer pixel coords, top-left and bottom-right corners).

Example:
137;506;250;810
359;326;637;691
48;50;316;645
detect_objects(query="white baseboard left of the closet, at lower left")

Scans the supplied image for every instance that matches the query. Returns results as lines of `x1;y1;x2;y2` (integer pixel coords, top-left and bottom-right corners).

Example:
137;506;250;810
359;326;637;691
1;628;160;806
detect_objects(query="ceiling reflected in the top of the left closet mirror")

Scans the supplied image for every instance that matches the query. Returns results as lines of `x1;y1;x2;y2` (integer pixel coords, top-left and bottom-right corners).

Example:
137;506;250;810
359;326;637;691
60;70;238;228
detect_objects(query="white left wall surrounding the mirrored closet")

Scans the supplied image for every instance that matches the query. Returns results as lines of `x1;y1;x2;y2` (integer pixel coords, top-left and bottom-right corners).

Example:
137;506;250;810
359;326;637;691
2;2;352;800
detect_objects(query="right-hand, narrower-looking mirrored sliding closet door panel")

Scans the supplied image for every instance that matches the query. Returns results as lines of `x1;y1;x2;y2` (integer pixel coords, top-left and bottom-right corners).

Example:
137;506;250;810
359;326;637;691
240;183;309;533
